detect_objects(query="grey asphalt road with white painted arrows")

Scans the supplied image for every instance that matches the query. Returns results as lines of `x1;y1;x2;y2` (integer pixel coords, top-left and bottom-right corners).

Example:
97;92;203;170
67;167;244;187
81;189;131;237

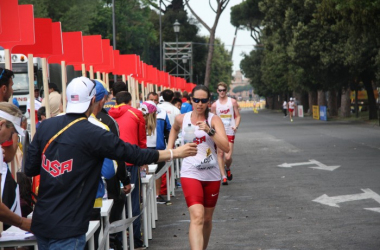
149;110;380;250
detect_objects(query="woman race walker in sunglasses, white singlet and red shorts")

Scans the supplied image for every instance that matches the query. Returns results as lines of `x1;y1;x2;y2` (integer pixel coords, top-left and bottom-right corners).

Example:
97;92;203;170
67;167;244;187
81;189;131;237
168;85;230;250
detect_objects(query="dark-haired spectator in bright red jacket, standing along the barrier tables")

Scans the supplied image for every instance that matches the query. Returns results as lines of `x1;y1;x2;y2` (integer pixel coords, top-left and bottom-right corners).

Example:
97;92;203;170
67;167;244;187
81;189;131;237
109;91;148;248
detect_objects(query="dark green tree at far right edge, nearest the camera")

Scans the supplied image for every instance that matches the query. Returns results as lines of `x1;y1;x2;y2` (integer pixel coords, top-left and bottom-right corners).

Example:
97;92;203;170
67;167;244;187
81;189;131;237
318;0;380;119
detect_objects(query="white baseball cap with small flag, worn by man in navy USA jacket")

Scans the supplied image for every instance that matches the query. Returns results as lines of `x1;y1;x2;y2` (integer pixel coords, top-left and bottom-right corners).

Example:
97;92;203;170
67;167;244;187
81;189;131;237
66;76;96;114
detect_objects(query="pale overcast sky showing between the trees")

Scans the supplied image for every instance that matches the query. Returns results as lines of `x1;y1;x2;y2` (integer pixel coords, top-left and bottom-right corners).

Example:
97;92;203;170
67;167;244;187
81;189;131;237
185;0;255;74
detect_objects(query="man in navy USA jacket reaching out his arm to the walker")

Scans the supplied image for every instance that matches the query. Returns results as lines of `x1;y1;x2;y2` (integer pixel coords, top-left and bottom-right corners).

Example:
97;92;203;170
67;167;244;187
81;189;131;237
25;77;196;250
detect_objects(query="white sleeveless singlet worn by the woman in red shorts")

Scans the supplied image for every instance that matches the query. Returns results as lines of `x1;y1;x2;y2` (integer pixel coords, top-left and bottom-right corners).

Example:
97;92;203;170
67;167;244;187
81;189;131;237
181;112;220;181
